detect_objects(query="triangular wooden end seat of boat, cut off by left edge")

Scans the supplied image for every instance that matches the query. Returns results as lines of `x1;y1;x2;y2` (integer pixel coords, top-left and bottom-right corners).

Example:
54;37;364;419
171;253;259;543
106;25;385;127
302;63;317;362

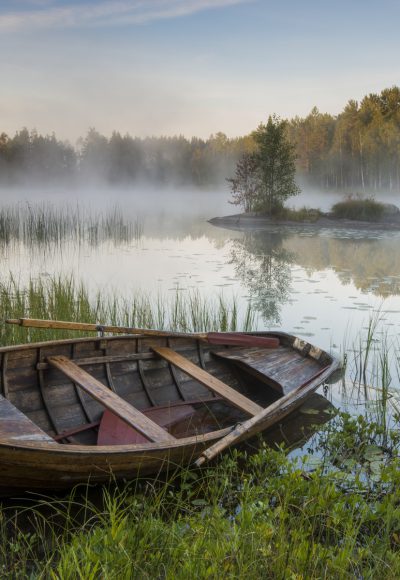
0;395;56;444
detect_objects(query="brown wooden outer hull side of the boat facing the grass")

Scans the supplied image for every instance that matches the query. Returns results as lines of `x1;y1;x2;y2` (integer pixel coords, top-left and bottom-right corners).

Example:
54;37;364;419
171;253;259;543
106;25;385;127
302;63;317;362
0;428;230;493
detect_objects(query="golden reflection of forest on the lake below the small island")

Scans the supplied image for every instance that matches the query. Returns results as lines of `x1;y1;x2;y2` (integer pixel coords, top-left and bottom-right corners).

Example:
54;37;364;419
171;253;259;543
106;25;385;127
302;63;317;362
223;226;400;298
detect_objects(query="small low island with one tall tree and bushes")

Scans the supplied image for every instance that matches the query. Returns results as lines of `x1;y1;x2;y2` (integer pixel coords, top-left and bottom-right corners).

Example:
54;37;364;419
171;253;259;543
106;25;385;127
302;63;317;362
209;115;400;229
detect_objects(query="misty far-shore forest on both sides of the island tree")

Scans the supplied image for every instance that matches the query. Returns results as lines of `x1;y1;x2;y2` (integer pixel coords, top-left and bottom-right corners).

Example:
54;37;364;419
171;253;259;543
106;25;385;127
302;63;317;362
0;86;400;193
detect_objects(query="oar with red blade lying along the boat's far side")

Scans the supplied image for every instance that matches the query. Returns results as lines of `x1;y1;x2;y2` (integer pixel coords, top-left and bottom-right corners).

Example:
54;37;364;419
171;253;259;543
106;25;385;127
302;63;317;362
6;318;279;348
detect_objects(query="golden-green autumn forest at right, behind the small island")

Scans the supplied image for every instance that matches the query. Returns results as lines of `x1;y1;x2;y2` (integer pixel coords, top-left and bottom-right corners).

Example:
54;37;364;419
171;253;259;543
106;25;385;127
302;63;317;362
288;86;400;191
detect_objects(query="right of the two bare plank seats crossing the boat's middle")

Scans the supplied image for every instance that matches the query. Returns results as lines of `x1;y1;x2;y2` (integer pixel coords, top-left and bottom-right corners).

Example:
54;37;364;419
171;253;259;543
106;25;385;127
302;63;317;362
153;347;263;416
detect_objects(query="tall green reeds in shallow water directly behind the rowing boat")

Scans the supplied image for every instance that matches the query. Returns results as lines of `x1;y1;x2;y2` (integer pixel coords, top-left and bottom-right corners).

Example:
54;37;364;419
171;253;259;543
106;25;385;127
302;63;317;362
0;277;255;345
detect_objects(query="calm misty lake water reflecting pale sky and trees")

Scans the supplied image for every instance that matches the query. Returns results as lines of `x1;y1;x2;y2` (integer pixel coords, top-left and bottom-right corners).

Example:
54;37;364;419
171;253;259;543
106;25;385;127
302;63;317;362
0;189;400;426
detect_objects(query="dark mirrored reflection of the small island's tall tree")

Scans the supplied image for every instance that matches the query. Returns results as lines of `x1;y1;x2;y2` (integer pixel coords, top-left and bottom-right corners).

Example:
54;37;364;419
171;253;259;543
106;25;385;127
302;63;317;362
231;231;296;325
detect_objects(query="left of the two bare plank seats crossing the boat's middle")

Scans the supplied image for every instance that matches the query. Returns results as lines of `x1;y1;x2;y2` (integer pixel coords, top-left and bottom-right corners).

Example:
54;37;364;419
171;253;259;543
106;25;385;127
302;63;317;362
47;356;176;443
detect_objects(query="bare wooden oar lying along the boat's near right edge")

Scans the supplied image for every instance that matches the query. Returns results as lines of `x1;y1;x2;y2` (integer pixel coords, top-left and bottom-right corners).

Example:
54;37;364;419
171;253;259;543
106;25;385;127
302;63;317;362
194;363;336;467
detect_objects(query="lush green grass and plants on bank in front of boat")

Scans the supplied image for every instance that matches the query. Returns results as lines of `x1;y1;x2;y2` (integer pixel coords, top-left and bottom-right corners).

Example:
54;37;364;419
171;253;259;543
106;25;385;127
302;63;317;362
0;415;400;580
